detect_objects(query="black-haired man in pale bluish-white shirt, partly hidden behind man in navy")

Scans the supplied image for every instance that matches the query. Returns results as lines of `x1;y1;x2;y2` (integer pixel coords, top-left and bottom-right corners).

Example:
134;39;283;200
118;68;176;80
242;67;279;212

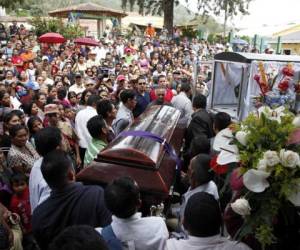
29;127;62;213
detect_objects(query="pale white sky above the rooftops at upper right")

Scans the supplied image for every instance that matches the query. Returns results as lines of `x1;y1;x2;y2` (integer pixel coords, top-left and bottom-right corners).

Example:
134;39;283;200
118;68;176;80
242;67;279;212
180;0;300;28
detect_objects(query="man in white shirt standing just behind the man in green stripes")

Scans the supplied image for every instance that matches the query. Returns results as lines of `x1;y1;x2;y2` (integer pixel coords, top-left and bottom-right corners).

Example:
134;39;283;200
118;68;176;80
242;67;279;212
75;95;101;162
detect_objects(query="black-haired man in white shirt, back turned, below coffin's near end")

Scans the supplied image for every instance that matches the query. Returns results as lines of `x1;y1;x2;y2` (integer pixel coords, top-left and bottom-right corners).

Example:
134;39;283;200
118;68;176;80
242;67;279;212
101;177;169;250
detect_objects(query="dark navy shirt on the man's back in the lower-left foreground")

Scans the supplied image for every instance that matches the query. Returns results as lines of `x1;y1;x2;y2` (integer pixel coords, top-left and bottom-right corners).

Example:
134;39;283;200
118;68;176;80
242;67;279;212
32;183;111;250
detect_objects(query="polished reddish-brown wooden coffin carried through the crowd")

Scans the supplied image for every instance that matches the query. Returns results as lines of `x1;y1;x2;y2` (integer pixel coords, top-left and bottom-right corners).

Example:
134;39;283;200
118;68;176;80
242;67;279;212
77;106;185;196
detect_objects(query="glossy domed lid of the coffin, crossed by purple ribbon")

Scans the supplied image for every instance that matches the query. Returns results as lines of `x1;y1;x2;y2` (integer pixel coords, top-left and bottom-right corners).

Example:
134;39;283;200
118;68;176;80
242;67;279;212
96;105;180;170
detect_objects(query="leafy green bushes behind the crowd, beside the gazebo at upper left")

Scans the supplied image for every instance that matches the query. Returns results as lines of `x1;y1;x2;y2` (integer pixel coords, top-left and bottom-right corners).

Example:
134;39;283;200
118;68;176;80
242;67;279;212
31;16;84;39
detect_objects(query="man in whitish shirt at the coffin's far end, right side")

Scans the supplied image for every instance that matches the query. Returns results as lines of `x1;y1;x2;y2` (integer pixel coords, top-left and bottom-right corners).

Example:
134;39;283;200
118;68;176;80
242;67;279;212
171;83;193;122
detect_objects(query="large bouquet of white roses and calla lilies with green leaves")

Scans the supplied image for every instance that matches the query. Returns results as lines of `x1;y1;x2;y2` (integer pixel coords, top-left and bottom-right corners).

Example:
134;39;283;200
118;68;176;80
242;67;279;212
215;106;300;248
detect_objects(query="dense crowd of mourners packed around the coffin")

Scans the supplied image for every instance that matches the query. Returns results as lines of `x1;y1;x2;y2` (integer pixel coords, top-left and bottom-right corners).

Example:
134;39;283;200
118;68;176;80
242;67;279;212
0;23;286;250
